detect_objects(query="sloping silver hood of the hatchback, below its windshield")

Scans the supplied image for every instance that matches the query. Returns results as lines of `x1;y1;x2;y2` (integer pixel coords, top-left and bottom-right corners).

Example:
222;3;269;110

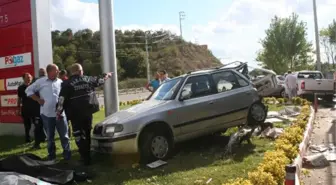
102;100;167;124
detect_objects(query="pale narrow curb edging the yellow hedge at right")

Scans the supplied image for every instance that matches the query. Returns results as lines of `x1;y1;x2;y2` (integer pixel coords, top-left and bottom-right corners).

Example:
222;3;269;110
293;106;316;184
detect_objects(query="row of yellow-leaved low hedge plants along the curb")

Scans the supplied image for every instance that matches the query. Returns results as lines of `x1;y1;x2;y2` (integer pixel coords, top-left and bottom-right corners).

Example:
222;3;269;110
224;97;311;185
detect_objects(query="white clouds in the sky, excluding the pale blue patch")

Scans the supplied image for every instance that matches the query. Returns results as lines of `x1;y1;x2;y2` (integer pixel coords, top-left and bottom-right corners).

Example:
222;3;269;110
52;0;336;68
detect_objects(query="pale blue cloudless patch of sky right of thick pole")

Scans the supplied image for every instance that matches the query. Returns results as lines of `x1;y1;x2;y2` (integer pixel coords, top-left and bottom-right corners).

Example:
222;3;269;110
81;0;231;26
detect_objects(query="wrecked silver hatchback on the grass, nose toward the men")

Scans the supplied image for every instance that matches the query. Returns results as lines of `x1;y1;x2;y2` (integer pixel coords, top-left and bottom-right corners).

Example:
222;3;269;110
92;68;267;162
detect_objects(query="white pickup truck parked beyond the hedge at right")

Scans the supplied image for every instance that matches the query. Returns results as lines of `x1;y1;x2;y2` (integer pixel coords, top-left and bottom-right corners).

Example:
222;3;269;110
295;71;336;102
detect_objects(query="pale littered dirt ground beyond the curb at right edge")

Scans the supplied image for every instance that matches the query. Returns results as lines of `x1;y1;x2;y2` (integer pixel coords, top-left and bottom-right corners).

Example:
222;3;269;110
302;105;336;185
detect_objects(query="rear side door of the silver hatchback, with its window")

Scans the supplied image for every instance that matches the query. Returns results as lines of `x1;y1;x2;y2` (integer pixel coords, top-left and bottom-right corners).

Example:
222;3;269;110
211;70;253;127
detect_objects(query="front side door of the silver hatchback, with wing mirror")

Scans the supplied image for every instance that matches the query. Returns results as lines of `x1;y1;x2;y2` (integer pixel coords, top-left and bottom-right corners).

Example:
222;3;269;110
175;75;216;137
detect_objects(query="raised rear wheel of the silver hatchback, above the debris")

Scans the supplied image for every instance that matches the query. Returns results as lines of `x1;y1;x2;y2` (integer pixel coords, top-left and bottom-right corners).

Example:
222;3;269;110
247;102;268;126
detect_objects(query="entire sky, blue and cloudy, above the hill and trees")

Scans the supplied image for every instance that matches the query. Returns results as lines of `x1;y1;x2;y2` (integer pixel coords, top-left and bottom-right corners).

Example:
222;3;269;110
51;0;336;66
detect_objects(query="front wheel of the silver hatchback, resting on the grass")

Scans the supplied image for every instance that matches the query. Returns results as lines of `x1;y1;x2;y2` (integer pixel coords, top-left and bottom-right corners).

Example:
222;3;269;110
139;128;173;164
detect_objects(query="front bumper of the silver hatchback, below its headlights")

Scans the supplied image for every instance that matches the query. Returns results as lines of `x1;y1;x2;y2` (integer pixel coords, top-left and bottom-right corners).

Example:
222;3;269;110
91;133;138;154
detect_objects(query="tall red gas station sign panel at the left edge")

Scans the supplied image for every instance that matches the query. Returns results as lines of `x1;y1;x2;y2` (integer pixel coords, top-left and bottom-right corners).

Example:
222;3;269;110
0;0;34;123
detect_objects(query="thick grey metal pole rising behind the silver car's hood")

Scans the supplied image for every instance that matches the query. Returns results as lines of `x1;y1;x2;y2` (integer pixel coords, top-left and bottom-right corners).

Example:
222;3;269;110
99;0;119;116
